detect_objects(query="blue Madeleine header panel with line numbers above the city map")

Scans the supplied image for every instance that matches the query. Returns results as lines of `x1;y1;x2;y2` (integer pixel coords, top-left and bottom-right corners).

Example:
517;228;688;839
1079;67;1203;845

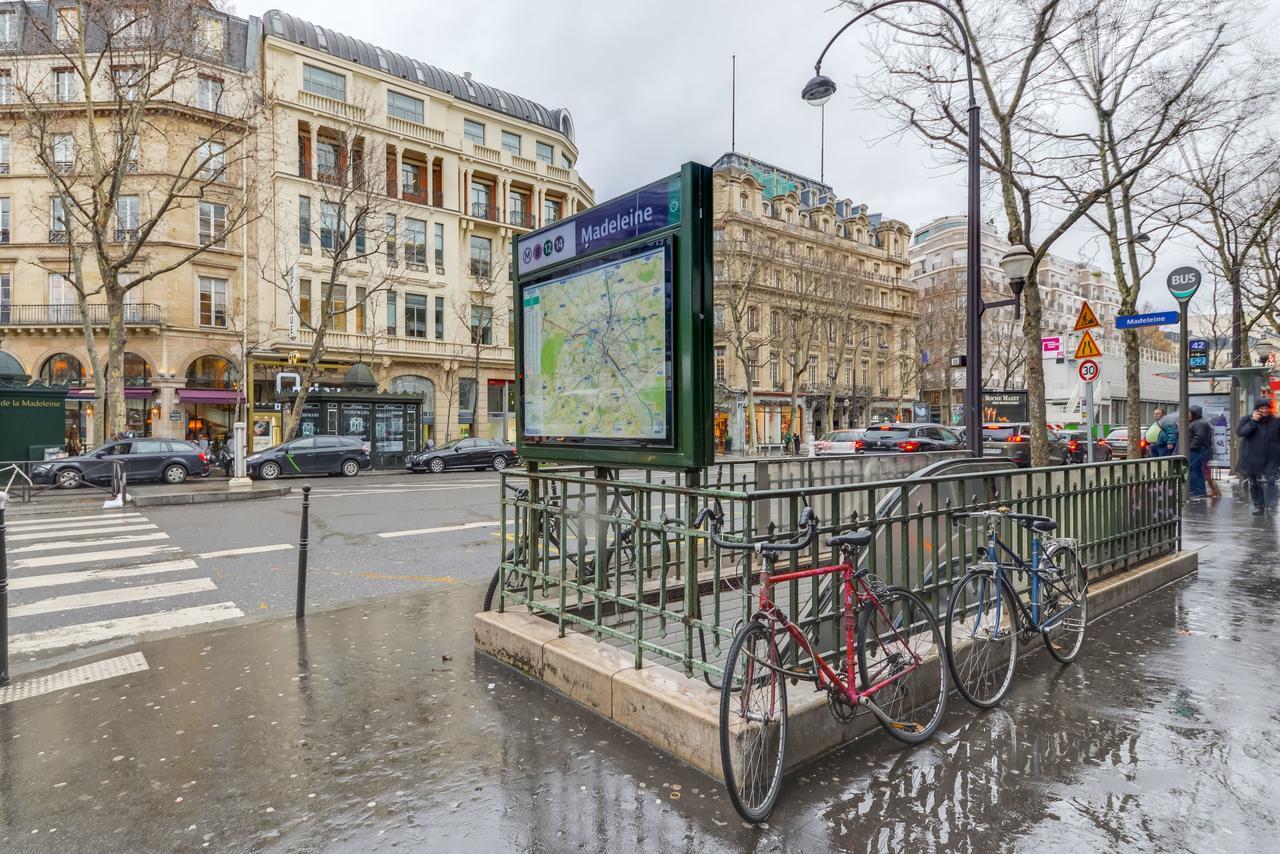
517;175;680;274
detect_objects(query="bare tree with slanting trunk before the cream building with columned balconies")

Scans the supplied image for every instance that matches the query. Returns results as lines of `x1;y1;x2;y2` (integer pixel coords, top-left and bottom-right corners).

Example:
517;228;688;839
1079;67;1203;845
267;96;407;439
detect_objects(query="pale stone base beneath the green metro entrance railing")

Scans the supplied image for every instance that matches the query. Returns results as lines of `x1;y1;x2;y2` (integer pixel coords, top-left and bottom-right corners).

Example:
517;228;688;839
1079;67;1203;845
474;552;1198;780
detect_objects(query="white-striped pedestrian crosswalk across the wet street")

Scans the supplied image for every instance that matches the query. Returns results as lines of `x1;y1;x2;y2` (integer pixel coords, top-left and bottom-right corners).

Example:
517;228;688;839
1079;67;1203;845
6;510;244;656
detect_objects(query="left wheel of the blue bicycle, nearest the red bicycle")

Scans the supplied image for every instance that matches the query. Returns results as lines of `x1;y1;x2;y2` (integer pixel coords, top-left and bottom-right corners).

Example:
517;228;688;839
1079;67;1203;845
945;570;1018;709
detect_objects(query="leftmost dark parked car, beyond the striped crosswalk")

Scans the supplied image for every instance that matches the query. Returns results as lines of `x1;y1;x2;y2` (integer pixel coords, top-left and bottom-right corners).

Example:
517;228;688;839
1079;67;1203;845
31;438;209;489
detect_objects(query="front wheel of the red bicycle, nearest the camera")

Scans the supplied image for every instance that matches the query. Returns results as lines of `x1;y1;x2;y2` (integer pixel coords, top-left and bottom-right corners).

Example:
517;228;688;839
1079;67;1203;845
721;620;787;822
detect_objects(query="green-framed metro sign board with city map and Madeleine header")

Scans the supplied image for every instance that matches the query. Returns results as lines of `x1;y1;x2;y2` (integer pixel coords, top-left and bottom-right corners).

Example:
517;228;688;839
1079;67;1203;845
511;163;714;470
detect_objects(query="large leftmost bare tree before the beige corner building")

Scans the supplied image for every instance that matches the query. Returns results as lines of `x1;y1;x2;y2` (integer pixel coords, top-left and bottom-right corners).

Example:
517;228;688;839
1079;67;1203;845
13;0;256;434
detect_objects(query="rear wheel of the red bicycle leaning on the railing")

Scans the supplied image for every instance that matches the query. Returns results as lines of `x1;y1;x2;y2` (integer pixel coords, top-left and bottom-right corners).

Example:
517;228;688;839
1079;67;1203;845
858;588;947;744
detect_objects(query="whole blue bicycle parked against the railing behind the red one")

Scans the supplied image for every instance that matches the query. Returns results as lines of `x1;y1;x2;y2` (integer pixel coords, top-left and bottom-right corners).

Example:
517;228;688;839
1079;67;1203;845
943;507;1089;708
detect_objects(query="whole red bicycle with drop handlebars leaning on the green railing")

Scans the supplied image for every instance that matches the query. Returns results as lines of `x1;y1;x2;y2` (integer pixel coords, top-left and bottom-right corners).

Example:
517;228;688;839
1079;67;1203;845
694;503;947;822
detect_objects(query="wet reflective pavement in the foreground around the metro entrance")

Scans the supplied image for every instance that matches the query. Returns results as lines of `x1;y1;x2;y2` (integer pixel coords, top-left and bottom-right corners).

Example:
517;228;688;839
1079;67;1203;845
0;491;1280;854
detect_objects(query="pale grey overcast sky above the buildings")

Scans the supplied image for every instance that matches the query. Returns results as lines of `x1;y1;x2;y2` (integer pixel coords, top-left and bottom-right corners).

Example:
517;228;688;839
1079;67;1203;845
233;0;1280;313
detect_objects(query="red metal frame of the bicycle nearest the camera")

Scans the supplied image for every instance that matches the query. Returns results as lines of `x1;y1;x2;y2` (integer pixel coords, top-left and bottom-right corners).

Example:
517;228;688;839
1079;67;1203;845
754;558;924;705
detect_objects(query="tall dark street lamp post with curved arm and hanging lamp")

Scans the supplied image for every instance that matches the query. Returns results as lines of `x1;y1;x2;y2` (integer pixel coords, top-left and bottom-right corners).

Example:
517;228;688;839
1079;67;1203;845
801;0;982;456
